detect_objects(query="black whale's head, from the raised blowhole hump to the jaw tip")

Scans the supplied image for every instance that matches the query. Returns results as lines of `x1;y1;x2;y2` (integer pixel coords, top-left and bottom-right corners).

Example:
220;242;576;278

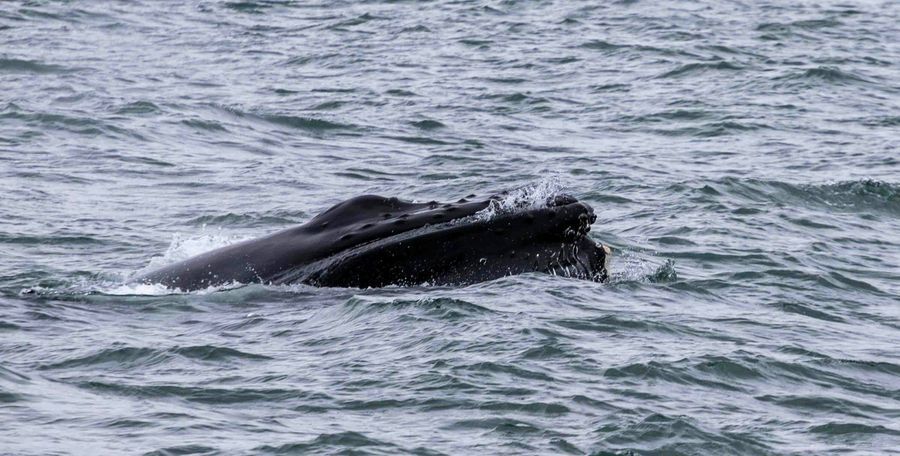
296;191;610;288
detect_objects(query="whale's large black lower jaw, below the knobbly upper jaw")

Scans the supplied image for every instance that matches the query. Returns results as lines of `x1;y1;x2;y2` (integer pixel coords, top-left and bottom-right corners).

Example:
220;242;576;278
301;197;610;288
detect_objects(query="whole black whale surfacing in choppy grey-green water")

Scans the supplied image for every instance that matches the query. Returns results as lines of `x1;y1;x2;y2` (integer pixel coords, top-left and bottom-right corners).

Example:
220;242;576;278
132;192;611;291
